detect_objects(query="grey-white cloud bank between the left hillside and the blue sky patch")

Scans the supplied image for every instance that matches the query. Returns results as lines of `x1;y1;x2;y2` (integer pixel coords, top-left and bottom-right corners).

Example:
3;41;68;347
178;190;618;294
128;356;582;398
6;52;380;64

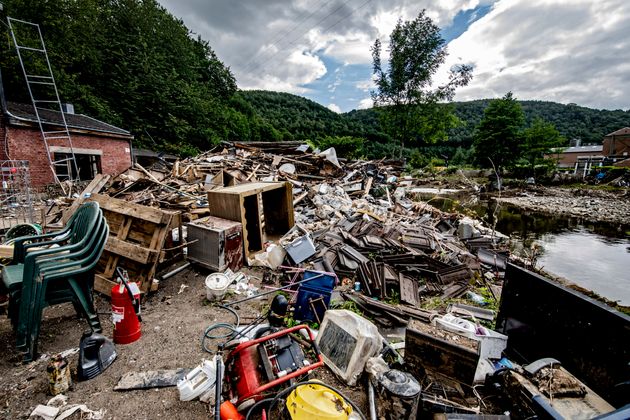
159;0;490;93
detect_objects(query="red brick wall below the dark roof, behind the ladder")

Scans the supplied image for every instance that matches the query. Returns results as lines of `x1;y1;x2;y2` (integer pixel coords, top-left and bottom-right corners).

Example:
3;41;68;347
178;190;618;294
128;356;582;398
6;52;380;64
2;126;131;187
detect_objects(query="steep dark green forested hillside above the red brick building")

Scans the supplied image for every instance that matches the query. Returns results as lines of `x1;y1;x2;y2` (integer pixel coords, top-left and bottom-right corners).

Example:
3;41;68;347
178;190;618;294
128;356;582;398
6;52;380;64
0;0;279;154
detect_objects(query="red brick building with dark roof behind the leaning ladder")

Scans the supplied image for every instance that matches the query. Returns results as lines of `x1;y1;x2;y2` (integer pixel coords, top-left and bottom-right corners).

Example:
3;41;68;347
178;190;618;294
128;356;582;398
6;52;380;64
0;100;133;187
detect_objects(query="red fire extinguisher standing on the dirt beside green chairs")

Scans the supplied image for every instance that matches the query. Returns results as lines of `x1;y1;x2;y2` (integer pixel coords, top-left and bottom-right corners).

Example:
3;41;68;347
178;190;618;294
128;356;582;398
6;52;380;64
112;267;142;344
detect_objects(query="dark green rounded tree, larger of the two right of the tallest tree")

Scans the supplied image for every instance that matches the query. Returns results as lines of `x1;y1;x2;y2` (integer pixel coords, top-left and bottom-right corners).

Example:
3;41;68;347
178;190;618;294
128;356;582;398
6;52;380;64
473;92;525;171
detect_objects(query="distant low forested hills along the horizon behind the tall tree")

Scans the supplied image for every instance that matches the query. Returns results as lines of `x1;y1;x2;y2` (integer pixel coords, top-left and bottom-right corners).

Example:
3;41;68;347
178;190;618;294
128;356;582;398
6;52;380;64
239;90;630;154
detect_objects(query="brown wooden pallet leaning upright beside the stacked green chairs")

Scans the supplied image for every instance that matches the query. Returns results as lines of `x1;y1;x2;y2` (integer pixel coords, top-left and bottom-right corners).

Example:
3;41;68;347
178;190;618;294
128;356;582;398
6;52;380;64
88;194;176;296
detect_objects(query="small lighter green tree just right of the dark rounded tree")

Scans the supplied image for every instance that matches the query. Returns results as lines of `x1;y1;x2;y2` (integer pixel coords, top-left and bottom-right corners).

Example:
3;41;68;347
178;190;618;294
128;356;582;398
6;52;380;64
522;118;564;176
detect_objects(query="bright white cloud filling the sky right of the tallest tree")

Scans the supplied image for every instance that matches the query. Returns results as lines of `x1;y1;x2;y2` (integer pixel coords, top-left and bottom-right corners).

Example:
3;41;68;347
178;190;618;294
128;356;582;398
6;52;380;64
441;0;630;108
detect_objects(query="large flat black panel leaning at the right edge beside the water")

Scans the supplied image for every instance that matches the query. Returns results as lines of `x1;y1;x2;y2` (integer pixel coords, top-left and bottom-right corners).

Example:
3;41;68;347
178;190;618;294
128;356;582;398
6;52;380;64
496;263;630;407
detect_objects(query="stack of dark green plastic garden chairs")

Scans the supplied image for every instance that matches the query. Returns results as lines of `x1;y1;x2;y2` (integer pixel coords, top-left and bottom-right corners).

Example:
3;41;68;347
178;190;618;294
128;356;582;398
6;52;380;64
2;203;109;361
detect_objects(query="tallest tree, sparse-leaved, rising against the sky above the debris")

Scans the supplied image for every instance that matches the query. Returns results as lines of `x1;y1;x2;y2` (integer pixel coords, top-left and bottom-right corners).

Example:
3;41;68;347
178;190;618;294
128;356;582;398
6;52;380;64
372;10;472;155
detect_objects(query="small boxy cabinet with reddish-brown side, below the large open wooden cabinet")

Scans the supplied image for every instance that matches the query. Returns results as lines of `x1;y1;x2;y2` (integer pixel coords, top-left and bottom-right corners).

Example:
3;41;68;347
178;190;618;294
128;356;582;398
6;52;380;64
186;216;243;272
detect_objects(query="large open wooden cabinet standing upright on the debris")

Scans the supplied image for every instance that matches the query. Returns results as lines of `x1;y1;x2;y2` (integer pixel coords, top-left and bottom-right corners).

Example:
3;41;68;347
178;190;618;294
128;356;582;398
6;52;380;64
208;182;294;258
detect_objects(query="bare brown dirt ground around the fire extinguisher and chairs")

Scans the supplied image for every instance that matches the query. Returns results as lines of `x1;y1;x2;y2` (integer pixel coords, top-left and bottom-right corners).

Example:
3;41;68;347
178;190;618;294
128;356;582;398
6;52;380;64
0;269;367;420
